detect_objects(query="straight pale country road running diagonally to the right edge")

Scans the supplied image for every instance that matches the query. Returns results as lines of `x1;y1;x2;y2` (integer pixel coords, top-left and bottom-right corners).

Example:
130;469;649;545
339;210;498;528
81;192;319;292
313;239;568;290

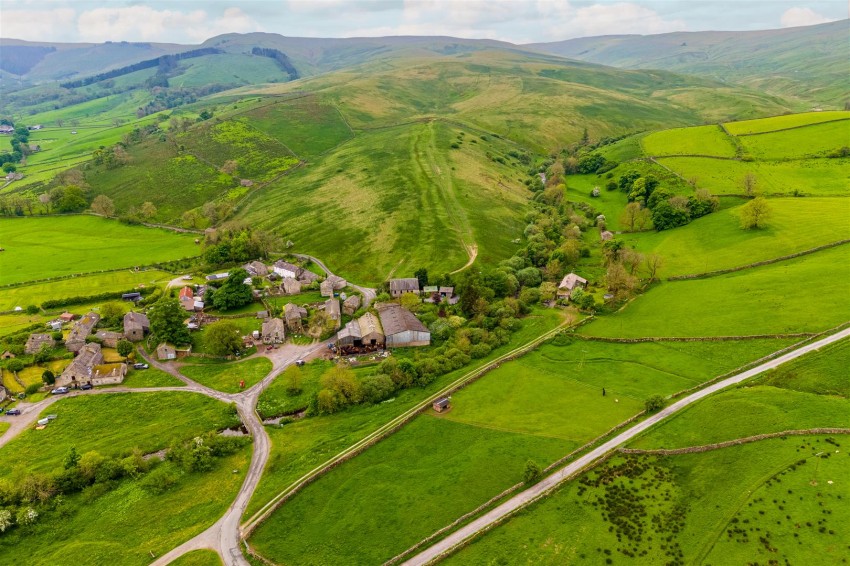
403;328;850;566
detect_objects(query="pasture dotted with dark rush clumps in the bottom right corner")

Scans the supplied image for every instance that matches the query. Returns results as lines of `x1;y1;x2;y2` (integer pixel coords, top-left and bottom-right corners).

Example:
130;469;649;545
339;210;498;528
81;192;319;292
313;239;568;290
445;436;850;566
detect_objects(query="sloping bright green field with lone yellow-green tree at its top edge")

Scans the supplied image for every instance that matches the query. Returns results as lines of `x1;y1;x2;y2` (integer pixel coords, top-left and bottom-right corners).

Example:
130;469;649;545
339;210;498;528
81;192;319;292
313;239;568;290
617;199;850;276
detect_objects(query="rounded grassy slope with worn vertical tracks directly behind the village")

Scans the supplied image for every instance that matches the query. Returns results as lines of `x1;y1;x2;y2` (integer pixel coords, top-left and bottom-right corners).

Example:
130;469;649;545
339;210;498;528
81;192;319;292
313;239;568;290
242;122;526;283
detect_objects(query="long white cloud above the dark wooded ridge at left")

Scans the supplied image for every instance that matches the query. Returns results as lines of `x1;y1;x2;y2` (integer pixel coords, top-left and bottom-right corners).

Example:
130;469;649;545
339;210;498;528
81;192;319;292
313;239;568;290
77;5;262;42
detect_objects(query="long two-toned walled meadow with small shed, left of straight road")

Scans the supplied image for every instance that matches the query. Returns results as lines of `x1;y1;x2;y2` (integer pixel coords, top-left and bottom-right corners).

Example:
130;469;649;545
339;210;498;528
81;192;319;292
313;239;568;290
247;337;796;563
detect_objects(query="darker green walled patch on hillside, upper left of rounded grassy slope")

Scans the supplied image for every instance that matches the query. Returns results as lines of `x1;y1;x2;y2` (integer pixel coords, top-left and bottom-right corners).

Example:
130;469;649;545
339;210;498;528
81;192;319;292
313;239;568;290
239;96;353;158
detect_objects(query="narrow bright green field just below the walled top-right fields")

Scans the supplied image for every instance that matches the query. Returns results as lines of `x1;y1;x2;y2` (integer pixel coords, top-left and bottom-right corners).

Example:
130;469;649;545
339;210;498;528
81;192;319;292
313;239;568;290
658;157;850;196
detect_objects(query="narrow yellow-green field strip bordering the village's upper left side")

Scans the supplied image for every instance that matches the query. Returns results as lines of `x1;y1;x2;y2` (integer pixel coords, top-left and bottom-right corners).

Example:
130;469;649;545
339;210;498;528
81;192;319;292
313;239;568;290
0;270;174;311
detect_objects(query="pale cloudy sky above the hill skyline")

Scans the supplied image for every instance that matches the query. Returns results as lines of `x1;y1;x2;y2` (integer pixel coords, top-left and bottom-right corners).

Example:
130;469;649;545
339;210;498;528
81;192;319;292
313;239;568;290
0;0;848;44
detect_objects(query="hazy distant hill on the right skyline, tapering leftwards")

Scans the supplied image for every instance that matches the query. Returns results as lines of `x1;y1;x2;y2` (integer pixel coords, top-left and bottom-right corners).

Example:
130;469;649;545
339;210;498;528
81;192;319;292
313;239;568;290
523;20;850;107
